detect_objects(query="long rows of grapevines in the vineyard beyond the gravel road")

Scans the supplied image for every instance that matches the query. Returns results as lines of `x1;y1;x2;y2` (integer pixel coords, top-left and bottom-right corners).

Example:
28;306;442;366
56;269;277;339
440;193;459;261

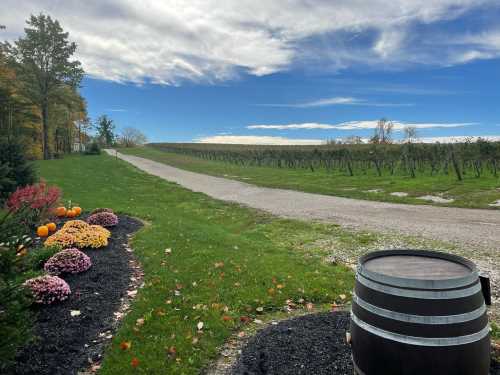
150;138;500;180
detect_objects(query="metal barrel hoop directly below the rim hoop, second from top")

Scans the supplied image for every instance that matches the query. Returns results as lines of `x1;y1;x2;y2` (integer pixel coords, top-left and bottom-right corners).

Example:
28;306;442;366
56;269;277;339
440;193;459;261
356;273;481;299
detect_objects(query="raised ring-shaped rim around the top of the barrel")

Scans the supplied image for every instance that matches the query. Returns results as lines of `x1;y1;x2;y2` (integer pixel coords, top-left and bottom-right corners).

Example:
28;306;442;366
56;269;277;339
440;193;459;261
358;249;479;287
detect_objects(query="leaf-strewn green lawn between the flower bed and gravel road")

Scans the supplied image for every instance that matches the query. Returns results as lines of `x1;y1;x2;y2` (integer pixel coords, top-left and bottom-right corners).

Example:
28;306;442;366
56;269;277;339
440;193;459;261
38;155;365;375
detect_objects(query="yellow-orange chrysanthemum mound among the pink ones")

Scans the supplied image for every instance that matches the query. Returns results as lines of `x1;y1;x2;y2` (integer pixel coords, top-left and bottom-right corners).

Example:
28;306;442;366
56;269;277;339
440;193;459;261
44;220;111;248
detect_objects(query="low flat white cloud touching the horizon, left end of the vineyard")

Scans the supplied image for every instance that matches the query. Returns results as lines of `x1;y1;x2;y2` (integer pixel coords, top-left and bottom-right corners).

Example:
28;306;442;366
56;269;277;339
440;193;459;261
194;135;325;145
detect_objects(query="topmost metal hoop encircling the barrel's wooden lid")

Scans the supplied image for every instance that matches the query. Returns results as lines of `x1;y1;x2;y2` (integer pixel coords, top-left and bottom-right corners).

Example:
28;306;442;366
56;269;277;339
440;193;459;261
357;250;479;289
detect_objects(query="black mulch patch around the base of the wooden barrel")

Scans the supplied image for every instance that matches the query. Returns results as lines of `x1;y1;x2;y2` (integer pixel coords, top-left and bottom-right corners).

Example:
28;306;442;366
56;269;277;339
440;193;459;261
232;312;500;375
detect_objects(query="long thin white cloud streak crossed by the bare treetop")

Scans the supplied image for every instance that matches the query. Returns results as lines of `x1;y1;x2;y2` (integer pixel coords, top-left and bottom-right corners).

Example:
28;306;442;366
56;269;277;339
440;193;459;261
247;120;478;131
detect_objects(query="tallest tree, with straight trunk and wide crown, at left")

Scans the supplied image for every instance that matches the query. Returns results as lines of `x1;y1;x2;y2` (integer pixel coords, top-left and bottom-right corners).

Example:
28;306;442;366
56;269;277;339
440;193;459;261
10;14;84;159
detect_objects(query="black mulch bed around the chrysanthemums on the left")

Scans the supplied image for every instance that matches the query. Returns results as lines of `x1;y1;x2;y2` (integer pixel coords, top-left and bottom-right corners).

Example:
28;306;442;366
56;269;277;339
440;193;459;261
13;215;142;375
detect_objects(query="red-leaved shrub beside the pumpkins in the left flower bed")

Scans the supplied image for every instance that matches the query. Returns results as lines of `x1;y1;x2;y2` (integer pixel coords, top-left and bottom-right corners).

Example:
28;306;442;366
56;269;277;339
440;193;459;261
6;181;61;227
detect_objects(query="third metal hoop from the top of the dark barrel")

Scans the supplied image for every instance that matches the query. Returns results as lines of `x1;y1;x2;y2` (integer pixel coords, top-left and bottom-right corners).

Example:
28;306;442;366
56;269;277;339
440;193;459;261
352;294;486;324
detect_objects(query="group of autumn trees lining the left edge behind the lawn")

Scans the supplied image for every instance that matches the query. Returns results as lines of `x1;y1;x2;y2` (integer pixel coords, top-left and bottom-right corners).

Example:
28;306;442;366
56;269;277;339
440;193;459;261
0;14;146;159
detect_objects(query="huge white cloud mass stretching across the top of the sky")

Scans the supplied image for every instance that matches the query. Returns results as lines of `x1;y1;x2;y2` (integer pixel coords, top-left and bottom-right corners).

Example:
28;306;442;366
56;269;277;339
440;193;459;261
0;0;500;83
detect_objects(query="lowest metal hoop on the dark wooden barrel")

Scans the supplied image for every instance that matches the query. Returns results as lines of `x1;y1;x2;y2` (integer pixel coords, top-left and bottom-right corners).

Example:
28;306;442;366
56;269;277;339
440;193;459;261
351;312;490;346
